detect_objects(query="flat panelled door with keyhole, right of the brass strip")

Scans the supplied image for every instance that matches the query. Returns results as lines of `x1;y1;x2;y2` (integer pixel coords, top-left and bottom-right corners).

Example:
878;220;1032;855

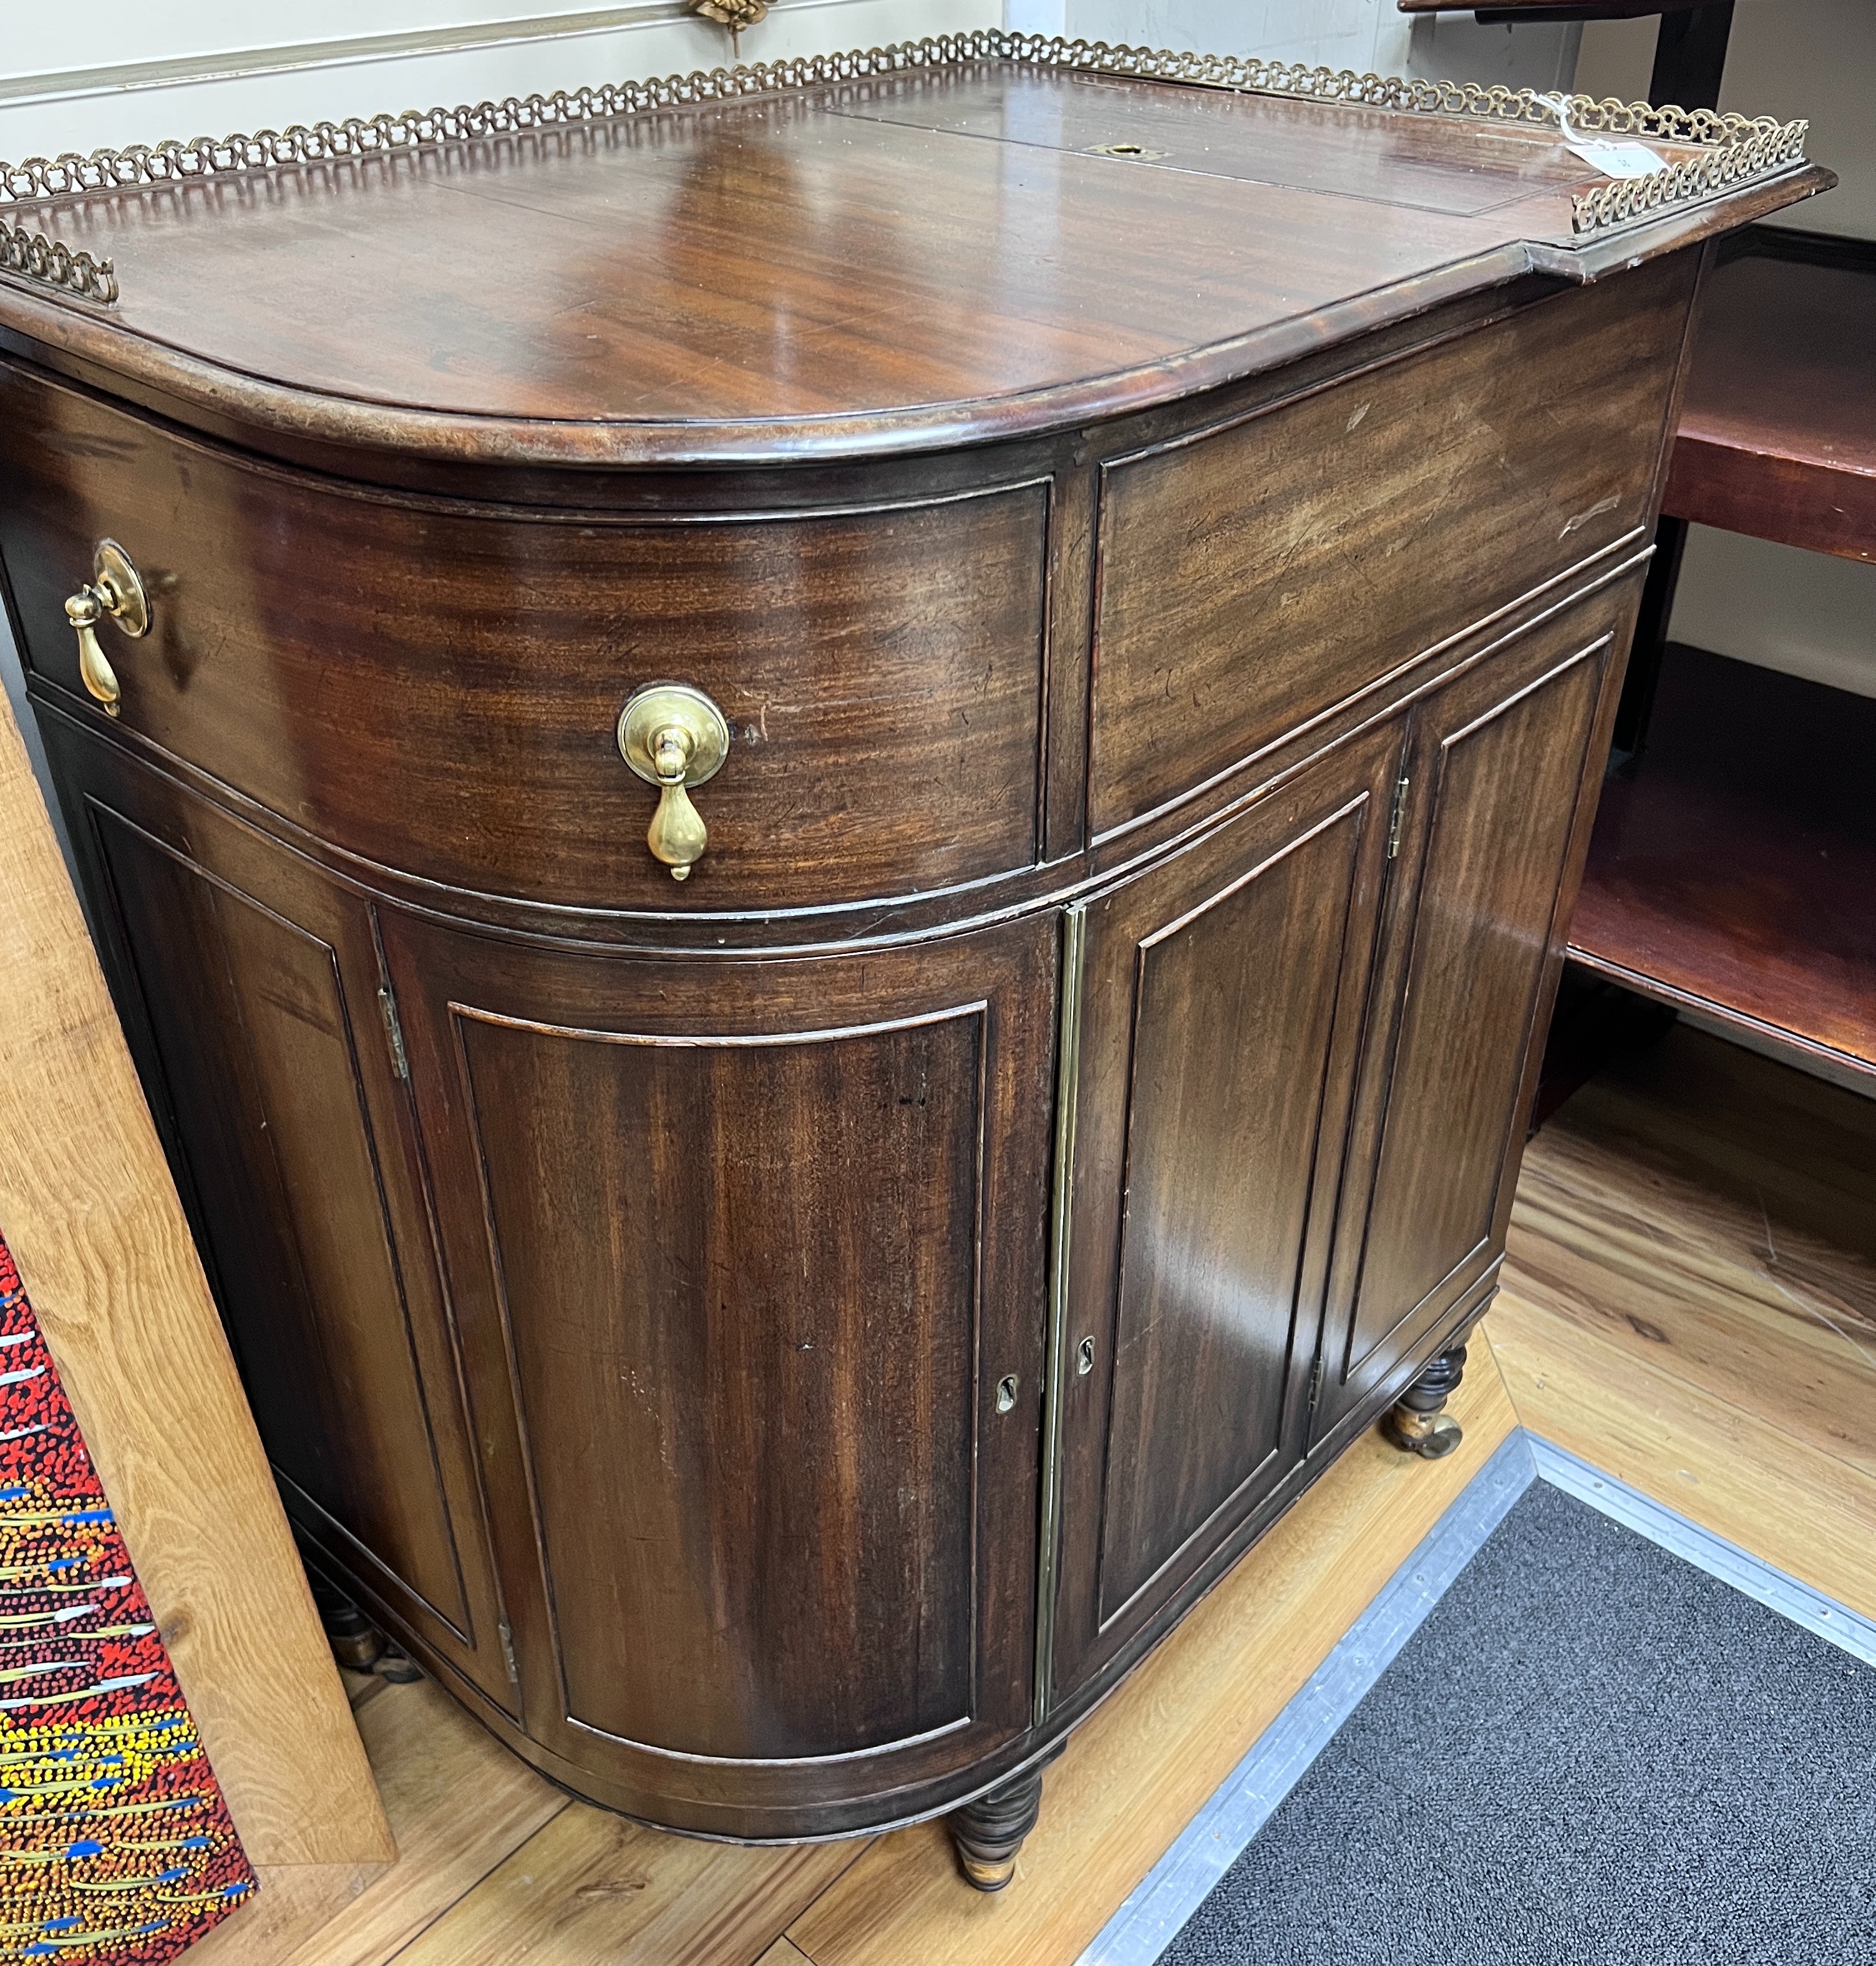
1054;719;1402;1696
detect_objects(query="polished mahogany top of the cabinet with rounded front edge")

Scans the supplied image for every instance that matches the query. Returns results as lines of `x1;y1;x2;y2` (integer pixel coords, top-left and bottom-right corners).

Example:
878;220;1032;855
0;34;1831;464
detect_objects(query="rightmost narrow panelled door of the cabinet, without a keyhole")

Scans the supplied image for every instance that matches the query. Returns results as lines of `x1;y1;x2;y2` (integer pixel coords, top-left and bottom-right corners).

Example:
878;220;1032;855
1314;582;1636;1439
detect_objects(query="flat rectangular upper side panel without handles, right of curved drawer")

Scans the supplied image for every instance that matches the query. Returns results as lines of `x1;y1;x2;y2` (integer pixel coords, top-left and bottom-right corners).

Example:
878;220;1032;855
1089;253;1695;835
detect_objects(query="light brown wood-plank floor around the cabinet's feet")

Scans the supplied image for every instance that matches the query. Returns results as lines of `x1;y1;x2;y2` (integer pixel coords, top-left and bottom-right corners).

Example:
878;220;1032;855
208;1028;1876;1966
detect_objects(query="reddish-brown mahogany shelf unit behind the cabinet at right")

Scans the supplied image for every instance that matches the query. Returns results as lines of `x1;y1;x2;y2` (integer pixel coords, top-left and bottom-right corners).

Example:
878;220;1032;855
1569;228;1876;1091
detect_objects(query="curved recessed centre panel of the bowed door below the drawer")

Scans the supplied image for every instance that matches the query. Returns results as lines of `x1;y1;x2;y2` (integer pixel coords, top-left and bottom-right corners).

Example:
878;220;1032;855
452;1005;979;1759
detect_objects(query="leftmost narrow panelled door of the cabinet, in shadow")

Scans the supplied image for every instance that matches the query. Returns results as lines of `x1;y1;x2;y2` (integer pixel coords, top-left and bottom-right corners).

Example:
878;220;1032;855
43;718;515;1708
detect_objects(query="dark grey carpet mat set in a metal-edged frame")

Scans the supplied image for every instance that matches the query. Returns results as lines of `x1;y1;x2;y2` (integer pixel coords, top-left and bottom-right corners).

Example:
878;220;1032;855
1162;1482;1876;1966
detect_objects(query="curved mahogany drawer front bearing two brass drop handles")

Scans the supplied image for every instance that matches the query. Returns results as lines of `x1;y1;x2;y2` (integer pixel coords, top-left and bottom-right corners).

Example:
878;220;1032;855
0;364;1048;910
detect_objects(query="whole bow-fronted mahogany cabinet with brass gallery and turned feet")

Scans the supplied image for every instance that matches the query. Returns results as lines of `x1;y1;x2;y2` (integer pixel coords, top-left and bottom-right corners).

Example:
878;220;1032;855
0;34;1831;1887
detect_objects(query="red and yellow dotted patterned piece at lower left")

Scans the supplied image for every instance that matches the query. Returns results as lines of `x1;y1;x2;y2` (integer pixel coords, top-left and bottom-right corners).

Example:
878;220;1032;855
0;1242;256;1966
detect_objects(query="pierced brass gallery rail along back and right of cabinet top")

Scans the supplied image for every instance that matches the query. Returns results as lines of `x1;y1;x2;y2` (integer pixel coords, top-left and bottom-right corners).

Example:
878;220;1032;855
0;27;1809;250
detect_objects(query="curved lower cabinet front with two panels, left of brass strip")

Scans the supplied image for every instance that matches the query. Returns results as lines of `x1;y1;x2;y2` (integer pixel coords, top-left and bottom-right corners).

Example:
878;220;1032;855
45;718;1058;1836
